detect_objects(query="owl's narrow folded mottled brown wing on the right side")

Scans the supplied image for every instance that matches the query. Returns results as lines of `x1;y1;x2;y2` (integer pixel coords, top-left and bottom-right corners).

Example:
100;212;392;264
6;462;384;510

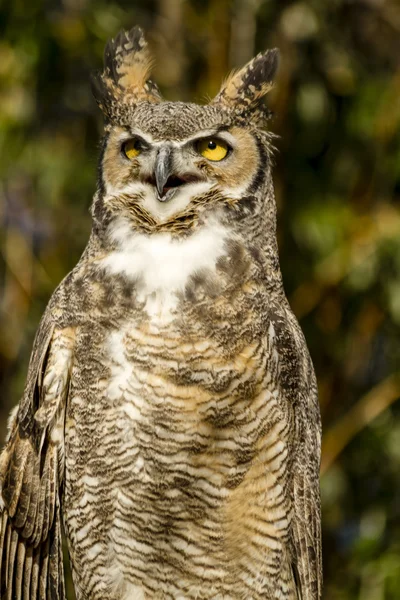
268;308;322;600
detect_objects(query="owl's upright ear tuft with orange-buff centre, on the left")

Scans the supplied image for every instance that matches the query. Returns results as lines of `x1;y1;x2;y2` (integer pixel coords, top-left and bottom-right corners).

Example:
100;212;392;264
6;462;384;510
92;27;161;117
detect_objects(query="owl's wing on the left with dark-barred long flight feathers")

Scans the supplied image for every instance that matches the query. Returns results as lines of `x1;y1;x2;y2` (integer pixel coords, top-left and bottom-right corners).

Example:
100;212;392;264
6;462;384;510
0;315;74;600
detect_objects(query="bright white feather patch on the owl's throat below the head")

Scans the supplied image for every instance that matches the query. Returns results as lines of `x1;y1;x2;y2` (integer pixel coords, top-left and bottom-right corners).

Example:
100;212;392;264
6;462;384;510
101;217;227;315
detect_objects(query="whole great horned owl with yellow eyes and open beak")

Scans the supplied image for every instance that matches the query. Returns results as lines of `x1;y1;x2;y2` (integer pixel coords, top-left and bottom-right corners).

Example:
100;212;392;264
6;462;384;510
0;28;321;600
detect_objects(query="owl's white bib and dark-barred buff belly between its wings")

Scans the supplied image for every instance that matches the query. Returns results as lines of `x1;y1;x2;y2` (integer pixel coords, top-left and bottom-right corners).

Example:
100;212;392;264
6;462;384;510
65;221;294;600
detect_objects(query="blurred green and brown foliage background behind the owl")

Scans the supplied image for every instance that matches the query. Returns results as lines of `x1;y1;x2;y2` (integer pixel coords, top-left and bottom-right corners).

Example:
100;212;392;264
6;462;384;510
0;0;400;600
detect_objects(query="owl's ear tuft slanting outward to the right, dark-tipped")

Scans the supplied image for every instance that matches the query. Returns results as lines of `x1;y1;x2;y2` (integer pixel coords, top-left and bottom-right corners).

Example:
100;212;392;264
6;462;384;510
212;48;279;113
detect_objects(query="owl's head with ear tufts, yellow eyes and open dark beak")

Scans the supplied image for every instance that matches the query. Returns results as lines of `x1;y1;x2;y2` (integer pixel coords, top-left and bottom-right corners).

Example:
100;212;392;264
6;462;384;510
92;27;278;235
